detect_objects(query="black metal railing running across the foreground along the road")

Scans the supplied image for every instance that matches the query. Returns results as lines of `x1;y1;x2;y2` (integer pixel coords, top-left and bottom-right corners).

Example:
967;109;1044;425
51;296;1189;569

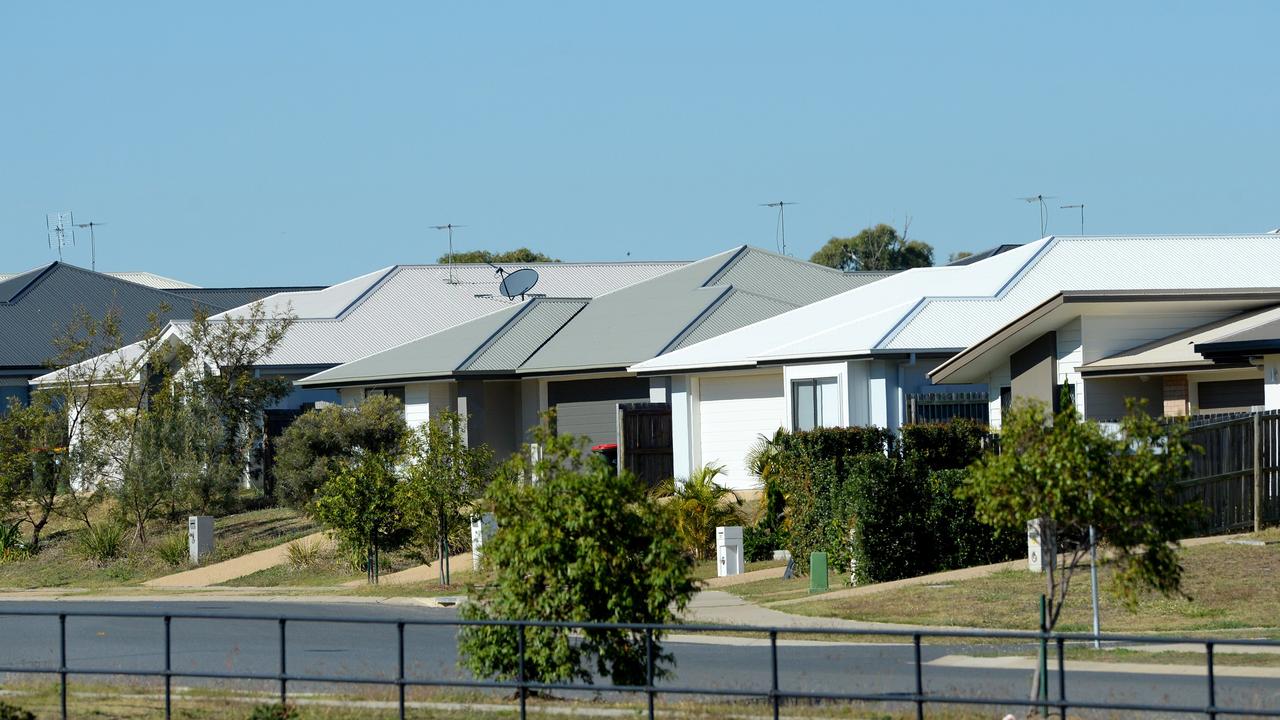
0;609;1280;720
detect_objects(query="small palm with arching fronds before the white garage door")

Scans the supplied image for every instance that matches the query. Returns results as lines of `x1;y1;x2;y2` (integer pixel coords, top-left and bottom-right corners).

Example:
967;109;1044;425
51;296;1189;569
654;465;742;560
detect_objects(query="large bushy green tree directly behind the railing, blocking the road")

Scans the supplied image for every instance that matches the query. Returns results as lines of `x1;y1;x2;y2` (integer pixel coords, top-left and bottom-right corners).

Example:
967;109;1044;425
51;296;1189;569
458;428;694;685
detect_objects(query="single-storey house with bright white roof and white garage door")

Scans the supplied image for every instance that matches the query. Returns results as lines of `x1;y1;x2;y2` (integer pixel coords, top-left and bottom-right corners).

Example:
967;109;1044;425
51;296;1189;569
631;234;1280;484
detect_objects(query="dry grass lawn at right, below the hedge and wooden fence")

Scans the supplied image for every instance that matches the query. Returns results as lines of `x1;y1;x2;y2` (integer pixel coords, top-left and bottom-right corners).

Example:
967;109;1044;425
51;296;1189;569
773;530;1280;637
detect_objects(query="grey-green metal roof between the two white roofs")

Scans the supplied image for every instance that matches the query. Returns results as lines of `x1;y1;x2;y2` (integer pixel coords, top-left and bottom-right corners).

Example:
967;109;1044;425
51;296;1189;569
301;246;884;386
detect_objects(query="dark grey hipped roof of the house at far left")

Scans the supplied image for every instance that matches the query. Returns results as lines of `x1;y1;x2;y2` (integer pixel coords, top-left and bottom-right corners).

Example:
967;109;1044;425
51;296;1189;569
0;263;317;374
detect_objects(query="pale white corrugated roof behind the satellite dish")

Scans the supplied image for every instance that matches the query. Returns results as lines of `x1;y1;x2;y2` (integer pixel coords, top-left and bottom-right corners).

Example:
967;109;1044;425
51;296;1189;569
217;261;686;365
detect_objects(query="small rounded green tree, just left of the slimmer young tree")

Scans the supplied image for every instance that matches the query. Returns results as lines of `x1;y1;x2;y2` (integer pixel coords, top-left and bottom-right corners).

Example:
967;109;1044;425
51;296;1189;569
311;452;410;583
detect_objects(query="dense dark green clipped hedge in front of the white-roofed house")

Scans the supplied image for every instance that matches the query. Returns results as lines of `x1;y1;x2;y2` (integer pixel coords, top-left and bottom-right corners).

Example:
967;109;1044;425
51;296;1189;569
778;420;1020;583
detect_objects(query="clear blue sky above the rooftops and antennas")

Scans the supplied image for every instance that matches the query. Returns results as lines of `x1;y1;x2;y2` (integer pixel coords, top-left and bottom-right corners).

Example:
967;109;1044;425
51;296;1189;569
0;1;1280;286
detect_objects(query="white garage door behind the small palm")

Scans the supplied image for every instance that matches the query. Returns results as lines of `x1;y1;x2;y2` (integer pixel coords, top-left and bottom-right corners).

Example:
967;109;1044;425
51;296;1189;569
698;373;786;489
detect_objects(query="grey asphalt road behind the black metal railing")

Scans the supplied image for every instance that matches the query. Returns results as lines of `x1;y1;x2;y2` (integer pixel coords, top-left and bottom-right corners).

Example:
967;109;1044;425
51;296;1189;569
0;601;1280;717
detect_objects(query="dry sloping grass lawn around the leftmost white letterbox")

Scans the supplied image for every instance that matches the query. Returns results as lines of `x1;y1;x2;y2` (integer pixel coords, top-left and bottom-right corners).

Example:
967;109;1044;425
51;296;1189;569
0;507;319;589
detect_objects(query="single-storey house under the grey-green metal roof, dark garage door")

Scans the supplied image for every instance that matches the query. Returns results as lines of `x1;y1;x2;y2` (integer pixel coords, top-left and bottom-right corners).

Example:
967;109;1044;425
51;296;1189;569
297;246;890;478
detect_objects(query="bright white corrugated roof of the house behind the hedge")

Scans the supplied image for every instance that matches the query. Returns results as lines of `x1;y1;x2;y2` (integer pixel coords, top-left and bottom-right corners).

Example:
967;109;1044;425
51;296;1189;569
632;234;1280;373
